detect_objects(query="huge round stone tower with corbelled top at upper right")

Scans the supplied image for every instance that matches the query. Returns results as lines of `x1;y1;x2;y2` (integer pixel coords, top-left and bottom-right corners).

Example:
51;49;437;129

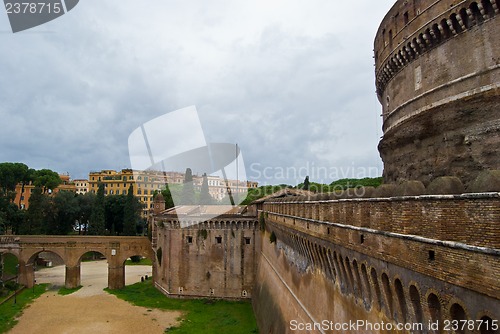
374;0;500;187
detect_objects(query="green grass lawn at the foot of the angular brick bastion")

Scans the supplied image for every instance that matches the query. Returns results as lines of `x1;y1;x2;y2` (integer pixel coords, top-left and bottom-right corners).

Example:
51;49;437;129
106;280;259;334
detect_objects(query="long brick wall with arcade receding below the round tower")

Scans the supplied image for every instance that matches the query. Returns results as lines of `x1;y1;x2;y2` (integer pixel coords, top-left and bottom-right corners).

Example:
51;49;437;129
254;194;500;333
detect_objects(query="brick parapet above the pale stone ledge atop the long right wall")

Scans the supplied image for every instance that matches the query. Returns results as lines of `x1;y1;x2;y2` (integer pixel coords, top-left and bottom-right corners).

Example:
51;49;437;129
264;193;500;248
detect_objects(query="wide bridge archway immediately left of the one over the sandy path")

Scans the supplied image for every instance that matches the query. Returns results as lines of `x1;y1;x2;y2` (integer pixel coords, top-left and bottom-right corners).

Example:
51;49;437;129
26;251;66;289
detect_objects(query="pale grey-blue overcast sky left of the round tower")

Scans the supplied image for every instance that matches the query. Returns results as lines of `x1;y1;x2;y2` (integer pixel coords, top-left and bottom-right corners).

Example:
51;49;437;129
0;0;395;184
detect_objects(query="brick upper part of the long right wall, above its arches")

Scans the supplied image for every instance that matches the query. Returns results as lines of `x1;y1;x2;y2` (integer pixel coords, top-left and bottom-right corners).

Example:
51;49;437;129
264;194;500;299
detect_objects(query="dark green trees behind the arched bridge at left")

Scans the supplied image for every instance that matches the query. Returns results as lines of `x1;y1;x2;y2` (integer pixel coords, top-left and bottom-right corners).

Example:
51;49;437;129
0;162;145;235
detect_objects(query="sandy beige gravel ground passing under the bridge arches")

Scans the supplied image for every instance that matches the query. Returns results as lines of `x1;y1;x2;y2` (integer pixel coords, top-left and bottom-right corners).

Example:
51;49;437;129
9;261;182;334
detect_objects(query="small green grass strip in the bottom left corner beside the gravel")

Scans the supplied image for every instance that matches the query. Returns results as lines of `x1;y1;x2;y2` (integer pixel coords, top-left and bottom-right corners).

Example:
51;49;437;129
0;284;47;333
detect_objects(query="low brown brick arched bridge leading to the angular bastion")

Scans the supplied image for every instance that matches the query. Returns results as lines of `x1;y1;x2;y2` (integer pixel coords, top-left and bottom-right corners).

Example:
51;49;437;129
0;235;153;289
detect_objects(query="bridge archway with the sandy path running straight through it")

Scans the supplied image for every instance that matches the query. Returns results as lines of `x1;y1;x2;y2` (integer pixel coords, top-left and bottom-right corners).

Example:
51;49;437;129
78;251;108;294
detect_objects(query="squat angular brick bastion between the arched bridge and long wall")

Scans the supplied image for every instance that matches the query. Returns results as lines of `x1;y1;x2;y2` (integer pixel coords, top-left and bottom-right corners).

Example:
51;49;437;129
153;215;260;299
